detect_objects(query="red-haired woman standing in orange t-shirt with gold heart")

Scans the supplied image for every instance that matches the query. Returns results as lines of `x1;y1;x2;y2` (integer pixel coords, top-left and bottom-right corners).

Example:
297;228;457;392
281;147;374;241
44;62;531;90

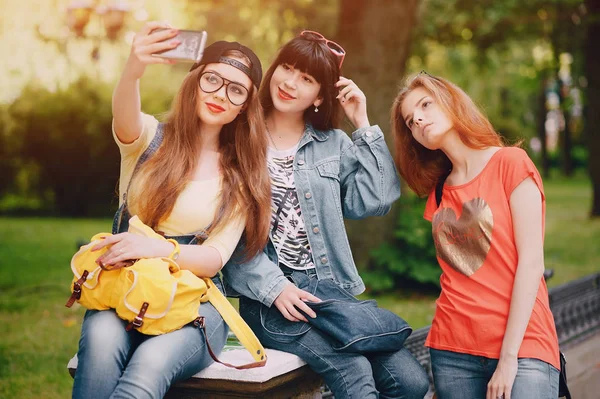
392;72;560;399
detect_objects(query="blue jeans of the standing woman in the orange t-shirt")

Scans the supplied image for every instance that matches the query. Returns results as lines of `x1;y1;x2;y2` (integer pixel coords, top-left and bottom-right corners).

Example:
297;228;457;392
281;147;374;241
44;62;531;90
429;349;558;399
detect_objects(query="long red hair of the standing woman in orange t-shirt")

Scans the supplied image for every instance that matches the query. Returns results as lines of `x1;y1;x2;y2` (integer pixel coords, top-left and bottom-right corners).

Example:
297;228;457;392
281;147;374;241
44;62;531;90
391;72;504;196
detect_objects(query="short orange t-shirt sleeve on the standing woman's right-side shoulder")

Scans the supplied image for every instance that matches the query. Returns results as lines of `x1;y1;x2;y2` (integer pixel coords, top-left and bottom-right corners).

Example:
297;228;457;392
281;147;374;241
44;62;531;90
502;147;546;201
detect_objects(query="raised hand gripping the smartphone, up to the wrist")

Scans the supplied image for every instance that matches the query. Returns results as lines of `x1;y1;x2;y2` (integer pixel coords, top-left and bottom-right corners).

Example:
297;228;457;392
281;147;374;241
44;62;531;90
123;21;181;79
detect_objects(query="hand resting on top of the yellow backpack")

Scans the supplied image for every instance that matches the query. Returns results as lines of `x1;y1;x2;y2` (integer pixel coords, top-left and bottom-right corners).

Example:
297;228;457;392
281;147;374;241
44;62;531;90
92;233;174;266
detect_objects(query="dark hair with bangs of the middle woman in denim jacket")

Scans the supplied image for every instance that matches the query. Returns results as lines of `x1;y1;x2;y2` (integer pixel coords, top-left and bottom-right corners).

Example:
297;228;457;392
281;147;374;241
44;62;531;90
258;36;342;130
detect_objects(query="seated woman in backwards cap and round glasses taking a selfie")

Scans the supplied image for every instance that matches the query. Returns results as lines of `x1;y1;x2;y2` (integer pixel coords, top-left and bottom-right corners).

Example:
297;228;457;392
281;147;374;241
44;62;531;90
73;22;270;399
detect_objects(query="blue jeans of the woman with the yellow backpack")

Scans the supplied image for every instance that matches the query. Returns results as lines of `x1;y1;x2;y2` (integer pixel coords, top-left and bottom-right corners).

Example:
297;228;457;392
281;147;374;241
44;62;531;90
73;303;227;399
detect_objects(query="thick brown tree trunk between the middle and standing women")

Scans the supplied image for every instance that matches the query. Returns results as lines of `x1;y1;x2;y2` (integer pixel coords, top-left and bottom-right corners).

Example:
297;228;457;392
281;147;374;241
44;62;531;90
336;0;419;267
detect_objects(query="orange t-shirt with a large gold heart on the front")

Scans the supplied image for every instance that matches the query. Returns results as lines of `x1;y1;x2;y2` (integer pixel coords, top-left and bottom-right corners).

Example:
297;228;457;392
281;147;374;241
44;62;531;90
424;147;560;369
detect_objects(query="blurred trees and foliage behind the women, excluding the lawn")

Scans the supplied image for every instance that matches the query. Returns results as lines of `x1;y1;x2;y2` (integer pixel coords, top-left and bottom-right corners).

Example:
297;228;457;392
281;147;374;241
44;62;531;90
0;0;600;292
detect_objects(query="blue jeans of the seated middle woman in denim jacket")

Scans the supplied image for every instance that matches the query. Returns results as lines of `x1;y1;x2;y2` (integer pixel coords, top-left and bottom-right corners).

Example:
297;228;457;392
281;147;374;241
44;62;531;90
240;272;429;399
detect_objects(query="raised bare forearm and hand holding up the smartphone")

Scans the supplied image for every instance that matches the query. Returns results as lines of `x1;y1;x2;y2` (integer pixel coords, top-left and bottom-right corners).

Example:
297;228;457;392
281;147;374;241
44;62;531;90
112;22;179;144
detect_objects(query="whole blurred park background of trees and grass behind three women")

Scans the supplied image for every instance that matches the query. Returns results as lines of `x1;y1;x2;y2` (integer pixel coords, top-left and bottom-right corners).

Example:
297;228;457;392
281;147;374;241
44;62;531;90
0;0;600;398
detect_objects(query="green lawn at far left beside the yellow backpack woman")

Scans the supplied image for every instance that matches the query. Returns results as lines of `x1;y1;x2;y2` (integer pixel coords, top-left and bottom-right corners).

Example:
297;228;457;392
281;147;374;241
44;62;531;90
0;218;110;398
